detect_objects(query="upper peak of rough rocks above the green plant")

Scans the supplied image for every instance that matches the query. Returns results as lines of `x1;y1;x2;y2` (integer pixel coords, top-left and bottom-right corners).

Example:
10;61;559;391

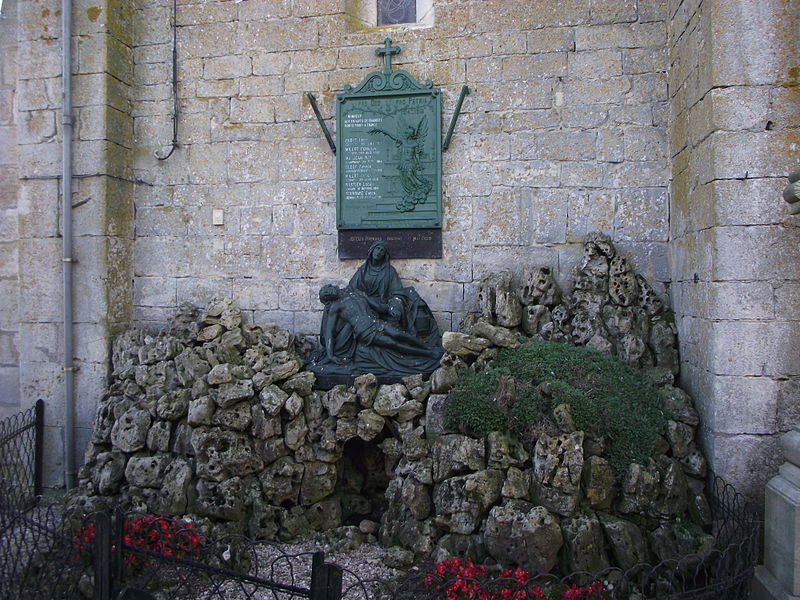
433;233;679;392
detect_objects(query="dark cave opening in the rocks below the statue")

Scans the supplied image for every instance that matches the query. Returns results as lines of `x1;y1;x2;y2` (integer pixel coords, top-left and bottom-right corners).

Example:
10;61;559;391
336;435;391;525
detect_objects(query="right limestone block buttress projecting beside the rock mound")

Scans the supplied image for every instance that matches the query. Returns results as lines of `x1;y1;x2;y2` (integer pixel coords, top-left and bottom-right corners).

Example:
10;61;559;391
669;0;800;498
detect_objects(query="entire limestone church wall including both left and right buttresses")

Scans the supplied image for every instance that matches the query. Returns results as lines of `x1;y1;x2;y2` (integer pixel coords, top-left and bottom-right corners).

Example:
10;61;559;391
0;0;800;502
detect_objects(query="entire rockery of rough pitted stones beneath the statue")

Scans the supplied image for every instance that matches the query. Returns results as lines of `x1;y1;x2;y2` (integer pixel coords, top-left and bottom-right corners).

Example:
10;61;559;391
73;236;714;571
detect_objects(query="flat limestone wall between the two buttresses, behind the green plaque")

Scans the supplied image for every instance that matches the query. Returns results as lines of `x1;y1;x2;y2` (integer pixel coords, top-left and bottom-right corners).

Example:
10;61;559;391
132;0;670;333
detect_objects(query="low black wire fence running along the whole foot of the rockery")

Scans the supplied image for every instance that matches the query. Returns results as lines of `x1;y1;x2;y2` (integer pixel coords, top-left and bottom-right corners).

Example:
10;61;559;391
0;479;759;600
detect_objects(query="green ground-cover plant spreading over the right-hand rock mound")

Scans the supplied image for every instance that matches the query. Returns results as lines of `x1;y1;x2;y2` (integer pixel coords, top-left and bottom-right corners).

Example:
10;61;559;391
445;342;666;473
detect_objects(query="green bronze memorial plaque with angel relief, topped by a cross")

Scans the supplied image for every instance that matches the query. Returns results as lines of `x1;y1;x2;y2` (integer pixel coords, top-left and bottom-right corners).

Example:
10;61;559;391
336;38;442;229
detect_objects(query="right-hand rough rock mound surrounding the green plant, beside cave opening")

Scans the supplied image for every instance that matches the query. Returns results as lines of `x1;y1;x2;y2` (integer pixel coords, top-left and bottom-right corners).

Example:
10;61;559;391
381;235;714;571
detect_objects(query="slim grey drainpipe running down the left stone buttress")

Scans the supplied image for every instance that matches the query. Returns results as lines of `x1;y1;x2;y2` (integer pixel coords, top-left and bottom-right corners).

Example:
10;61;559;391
61;0;76;490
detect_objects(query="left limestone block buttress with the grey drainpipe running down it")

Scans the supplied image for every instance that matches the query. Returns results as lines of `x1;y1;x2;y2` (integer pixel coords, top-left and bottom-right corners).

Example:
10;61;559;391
10;0;133;485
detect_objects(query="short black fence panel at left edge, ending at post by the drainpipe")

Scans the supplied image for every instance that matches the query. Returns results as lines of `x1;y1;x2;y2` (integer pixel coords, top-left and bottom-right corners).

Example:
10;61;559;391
0;400;44;520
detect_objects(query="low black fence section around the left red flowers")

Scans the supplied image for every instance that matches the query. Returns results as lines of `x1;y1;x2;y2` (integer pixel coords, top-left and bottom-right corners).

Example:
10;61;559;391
0;506;356;600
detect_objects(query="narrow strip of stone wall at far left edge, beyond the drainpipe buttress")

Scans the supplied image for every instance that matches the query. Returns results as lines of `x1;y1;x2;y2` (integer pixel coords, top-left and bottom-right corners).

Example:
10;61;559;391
0;2;19;419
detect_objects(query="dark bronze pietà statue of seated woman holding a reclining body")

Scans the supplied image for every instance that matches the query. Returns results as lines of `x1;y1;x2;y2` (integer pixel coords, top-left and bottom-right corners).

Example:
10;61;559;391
307;242;443;378
